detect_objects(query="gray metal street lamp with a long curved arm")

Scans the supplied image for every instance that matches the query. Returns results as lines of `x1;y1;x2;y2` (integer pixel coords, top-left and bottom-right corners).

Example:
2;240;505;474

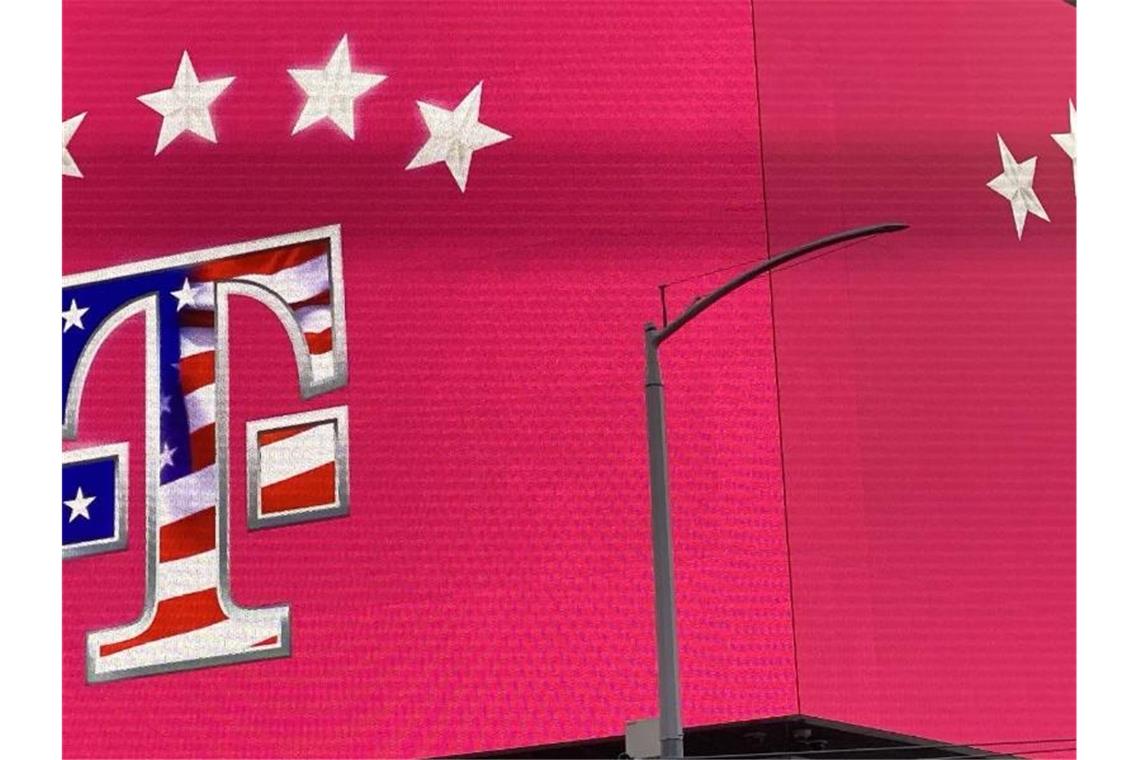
645;223;906;758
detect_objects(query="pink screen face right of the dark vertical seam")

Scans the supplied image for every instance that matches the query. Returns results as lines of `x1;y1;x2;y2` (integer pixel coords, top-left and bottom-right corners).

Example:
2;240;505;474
757;0;1076;757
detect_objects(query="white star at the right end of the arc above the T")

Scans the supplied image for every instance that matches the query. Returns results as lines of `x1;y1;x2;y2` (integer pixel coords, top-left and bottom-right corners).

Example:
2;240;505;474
405;82;511;191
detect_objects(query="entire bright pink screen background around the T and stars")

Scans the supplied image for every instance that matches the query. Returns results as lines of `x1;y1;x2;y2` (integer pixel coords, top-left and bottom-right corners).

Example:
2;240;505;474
63;0;1075;757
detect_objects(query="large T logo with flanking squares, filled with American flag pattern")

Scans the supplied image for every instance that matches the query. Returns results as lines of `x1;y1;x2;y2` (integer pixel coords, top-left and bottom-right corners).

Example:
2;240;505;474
63;227;348;681
